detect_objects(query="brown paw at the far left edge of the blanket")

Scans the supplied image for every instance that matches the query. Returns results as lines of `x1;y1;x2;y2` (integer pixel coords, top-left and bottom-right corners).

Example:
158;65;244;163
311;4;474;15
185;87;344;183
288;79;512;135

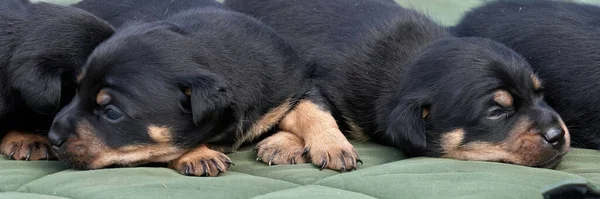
0;131;56;161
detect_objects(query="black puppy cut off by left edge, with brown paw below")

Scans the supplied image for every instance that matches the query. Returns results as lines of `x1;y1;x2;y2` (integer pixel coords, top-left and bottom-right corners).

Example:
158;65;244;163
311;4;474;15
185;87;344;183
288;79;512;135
0;0;113;160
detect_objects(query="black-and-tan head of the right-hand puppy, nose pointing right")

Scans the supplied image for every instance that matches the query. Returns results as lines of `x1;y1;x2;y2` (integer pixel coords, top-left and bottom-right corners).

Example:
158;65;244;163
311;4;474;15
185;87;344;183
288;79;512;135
387;38;570;167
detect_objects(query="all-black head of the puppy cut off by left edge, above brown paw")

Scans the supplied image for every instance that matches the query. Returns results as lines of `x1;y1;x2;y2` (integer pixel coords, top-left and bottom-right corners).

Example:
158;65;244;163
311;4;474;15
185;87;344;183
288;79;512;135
2;3;113;115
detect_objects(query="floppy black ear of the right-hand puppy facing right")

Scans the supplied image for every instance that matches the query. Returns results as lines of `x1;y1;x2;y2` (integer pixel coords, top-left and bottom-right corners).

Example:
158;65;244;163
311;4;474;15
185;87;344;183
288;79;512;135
385;95;427;156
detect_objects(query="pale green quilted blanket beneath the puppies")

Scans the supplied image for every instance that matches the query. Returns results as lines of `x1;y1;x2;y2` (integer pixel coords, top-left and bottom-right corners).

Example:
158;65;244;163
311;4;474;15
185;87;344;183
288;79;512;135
0;143;600;199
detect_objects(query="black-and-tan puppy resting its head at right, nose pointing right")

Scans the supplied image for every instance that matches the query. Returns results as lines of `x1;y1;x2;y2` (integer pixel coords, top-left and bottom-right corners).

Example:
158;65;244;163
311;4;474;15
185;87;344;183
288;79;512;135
225;0;569;168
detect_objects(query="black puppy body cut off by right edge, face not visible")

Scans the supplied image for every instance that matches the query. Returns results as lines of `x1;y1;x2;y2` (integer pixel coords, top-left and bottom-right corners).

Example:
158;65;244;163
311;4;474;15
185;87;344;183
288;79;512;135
455;1;600;149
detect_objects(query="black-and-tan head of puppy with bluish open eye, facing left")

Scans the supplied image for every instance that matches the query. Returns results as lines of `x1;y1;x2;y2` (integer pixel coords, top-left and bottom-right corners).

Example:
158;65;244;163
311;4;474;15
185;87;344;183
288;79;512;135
49;23;233;169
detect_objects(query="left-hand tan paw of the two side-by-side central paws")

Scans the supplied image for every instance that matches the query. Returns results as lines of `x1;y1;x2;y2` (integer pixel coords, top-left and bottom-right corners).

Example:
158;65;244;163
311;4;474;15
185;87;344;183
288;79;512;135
255;131;308;166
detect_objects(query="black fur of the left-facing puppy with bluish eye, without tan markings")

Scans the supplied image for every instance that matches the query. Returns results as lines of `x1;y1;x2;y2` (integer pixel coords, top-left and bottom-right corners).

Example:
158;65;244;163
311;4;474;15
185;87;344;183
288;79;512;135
50;1;309;168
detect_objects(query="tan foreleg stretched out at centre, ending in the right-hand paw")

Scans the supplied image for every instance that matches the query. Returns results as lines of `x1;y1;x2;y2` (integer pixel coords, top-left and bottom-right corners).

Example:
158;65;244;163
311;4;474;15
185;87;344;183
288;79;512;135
279;98;362;171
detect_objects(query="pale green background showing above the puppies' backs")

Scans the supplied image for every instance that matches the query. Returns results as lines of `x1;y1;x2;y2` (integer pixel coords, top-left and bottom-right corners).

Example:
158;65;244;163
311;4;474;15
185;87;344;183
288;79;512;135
33;0;600;25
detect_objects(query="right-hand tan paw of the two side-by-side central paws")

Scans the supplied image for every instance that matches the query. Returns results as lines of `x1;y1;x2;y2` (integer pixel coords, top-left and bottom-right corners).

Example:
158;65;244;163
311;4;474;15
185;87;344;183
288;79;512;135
306;131;362;172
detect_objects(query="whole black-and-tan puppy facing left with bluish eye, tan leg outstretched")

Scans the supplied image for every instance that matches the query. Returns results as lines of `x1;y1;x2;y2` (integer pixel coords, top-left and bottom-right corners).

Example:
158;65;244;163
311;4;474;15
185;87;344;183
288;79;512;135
49;1;360;176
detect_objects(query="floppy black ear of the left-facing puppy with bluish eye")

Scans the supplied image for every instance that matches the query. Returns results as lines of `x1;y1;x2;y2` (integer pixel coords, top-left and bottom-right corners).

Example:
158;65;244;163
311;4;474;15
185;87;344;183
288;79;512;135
181;71;232;126
